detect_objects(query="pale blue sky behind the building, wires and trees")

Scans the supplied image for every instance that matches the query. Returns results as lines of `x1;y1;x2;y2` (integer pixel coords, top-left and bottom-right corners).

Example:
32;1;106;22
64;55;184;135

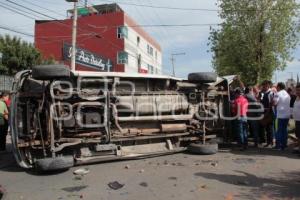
0;0;300;81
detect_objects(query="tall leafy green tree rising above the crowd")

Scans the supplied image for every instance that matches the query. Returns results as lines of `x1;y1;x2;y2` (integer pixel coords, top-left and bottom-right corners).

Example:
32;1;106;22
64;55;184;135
209;0;300;85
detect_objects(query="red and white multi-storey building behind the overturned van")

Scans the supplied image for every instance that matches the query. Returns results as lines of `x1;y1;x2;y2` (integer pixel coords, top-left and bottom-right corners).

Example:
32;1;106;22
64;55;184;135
35;4;162;74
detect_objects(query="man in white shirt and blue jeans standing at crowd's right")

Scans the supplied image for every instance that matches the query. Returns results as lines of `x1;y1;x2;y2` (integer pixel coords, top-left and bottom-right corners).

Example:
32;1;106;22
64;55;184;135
273;83;291;150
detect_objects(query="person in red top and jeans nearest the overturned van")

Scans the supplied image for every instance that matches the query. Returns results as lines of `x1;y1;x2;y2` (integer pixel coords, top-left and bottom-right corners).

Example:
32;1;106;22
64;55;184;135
232;88;249;149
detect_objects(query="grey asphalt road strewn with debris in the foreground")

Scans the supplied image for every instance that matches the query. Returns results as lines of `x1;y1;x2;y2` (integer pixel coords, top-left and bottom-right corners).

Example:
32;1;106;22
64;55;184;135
0;142;300;200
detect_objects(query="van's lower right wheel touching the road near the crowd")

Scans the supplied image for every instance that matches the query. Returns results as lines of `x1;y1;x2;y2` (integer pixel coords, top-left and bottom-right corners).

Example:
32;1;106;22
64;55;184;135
187;143;219;155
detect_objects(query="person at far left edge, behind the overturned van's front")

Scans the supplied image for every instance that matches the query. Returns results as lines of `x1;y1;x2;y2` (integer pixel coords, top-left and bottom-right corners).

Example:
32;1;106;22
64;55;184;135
0;92;8;151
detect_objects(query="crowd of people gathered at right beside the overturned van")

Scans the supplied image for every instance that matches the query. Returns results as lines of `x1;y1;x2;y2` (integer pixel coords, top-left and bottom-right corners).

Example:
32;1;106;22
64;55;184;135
232;80;300;154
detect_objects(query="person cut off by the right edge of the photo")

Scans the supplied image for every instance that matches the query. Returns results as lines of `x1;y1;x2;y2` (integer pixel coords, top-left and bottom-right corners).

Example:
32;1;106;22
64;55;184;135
292;84;300;154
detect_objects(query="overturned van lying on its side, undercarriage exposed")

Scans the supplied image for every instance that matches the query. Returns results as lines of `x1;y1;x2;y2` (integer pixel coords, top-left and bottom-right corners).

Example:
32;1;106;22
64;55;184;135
10;65;228;170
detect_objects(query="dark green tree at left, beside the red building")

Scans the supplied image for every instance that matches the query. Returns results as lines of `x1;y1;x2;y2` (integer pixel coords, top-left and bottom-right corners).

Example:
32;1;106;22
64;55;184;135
0;35;54;75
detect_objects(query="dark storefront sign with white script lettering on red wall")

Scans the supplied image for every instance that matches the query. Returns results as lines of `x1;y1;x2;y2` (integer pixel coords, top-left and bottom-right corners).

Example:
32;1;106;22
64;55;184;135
63;43;112;71
